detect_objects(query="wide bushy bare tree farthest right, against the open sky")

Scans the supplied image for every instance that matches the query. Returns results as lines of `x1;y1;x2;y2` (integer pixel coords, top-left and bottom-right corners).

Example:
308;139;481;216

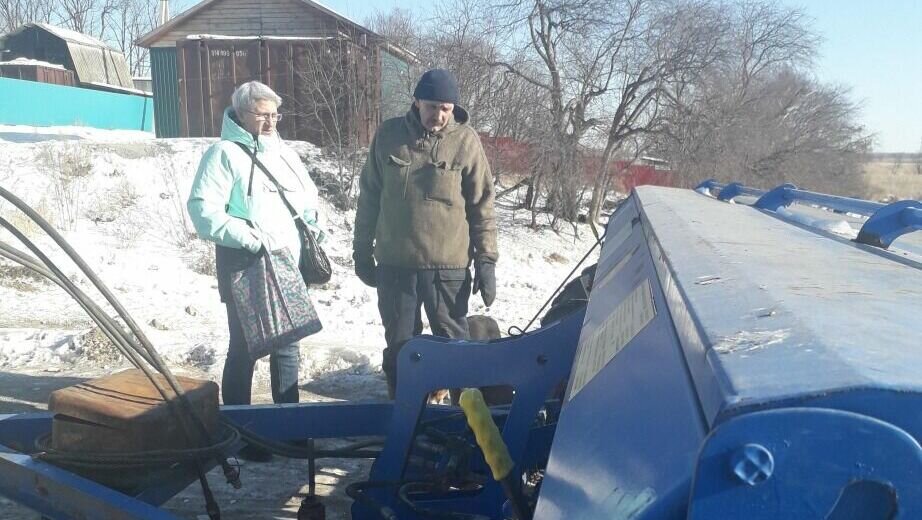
656;3;870;194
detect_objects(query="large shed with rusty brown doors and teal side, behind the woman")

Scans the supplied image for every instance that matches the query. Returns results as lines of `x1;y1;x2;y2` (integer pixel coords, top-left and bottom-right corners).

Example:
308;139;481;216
138;0;411;146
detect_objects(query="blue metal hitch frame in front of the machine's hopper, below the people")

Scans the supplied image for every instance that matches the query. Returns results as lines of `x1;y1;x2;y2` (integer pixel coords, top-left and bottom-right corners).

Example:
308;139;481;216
0;310;583;520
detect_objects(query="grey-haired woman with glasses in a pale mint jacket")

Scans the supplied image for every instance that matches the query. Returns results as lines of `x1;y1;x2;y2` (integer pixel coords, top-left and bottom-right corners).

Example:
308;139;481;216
187;81;322;460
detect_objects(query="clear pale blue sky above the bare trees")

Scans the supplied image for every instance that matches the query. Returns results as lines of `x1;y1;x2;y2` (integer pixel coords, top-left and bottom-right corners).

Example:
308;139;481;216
321;0;922;152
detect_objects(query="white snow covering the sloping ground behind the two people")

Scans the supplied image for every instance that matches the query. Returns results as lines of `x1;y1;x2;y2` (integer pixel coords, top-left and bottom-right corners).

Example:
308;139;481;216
0;127;594;394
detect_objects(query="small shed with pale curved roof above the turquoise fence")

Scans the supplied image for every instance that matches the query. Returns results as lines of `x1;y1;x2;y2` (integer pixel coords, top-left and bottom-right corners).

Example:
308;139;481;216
0;22;134;90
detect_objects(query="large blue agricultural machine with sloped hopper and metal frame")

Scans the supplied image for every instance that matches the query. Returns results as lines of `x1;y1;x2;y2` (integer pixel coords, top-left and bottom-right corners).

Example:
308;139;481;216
0;181;922;520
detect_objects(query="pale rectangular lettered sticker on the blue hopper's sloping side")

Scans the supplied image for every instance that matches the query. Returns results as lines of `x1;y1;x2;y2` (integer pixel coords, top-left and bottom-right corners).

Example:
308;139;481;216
567;278;656;401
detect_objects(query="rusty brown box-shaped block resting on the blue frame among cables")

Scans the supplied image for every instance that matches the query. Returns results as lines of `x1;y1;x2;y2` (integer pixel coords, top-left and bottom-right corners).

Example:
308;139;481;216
48;369;218;453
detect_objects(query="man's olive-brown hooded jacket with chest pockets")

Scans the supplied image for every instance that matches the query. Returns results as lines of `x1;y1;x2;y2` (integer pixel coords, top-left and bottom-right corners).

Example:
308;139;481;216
353;105;498;269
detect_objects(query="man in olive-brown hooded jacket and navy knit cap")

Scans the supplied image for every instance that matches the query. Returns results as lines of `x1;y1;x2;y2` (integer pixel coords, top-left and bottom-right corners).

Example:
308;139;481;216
352;69;498;398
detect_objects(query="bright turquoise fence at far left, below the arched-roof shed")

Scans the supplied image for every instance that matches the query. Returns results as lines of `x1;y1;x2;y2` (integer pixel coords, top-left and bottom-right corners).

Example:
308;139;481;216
0;78;154;132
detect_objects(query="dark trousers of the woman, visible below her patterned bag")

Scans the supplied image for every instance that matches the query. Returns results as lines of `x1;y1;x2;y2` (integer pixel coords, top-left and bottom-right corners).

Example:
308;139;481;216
221;303;301;404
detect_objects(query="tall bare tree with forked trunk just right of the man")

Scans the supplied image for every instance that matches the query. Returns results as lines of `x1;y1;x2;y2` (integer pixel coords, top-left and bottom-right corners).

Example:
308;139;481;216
481;0;624;225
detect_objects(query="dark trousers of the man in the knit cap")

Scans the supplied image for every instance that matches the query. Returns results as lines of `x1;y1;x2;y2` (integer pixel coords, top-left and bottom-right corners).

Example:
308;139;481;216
377;265;471;398
